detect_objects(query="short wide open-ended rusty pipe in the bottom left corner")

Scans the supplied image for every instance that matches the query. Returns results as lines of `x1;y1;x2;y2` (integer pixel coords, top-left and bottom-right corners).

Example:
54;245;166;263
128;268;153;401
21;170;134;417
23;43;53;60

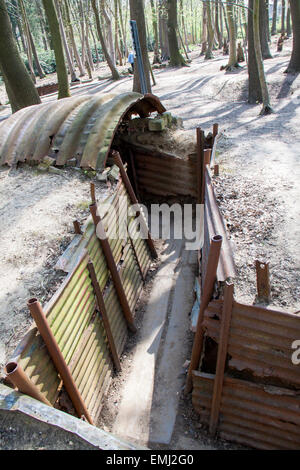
4;362;52;406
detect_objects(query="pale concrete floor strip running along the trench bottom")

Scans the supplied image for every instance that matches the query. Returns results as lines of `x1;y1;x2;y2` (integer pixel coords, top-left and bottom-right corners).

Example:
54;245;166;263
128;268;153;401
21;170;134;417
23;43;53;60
113;239;197;445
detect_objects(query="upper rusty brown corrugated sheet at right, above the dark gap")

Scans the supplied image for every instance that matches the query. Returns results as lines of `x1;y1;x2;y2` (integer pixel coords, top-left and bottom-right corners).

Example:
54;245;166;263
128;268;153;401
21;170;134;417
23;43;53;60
203;301;300;389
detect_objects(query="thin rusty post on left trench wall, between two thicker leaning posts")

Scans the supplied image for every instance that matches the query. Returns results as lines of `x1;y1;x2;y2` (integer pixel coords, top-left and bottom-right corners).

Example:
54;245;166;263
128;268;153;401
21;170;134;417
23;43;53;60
88;260;121;371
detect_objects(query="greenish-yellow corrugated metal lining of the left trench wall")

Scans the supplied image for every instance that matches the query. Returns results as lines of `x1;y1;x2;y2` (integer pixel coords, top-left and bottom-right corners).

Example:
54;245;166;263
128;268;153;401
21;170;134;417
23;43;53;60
7;181;151;421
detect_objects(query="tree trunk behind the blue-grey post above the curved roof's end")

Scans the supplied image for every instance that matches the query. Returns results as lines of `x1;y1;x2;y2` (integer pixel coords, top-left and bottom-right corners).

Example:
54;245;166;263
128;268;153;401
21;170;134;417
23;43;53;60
129;0;151;93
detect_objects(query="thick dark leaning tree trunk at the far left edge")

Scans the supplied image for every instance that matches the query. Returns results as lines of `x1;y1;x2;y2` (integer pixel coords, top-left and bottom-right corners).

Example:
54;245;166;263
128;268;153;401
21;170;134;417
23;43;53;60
0;0;41;112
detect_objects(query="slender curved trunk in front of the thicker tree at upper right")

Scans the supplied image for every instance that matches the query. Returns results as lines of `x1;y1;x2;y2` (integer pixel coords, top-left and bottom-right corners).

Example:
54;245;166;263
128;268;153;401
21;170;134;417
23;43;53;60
253;0;272;115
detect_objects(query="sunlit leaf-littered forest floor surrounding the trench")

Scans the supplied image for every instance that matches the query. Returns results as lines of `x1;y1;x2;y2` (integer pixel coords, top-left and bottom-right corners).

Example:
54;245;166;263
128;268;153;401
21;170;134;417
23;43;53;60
0;38;300;448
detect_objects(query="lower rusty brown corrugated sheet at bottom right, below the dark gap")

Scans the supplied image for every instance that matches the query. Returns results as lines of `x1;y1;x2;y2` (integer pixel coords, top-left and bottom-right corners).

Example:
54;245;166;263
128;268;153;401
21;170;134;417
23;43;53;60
192;371;300;450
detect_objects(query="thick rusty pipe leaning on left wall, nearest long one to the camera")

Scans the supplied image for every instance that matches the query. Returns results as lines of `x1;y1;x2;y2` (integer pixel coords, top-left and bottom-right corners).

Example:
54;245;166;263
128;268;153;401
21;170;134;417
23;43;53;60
27;298;94;424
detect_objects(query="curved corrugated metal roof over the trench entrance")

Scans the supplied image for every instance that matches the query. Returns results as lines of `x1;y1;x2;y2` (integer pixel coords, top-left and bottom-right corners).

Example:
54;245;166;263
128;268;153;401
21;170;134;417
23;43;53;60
0;92;165;169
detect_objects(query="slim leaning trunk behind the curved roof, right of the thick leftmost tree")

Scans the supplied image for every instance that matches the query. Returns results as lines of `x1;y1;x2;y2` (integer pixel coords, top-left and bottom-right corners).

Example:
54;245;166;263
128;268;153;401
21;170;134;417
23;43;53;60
43;0;70;99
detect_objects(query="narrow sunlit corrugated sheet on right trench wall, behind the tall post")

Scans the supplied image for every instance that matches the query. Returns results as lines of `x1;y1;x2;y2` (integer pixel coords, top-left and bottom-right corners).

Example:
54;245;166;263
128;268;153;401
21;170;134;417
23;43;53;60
201;169;236;283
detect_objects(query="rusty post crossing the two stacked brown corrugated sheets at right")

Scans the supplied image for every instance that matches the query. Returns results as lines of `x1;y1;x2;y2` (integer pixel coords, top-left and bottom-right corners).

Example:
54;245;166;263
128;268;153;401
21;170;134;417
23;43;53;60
209;282;234;436
